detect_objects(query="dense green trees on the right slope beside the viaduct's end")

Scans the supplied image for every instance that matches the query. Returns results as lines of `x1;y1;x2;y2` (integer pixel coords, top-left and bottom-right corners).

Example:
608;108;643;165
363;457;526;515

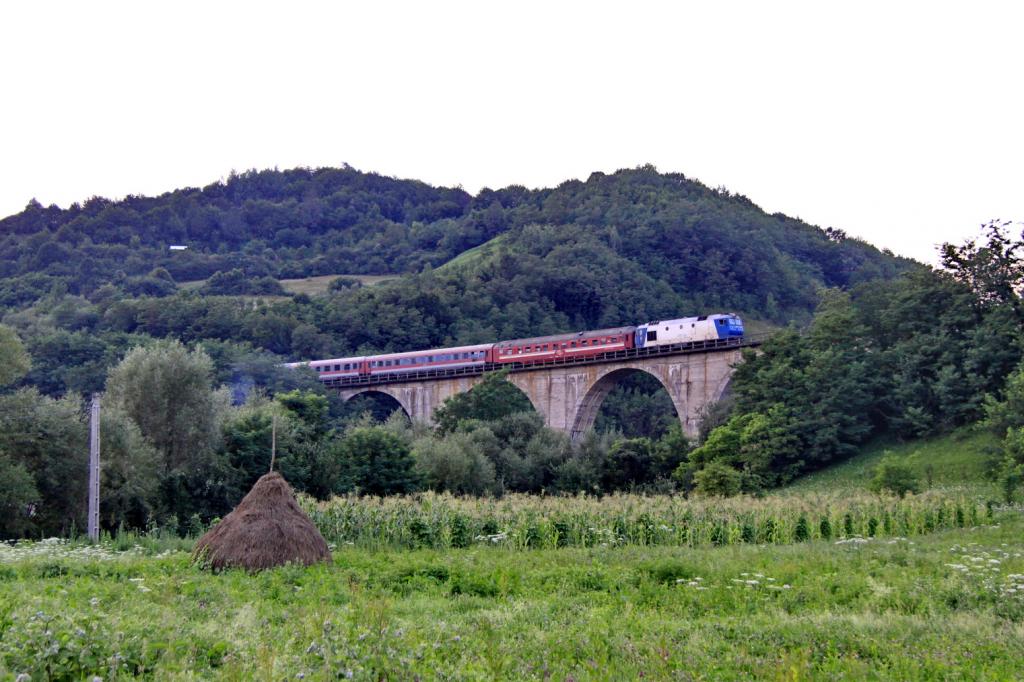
677;225;1024;491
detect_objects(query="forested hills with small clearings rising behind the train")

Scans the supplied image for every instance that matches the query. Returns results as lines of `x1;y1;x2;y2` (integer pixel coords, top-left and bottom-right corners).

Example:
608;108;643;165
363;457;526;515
0;167;910;395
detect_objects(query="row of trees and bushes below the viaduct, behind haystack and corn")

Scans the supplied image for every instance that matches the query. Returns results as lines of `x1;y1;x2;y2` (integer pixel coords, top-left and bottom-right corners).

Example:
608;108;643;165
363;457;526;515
0;327;686;538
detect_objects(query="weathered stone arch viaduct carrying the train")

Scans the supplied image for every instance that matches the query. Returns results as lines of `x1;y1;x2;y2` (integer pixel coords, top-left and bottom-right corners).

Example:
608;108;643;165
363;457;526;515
339;347;742;439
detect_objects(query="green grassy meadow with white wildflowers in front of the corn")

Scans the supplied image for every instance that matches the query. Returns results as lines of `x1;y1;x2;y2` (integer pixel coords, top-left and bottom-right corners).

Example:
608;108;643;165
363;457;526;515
0;512;1024;680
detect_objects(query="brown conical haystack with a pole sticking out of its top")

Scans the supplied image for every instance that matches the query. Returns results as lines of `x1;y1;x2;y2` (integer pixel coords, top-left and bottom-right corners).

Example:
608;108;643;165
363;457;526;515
193;471;331;570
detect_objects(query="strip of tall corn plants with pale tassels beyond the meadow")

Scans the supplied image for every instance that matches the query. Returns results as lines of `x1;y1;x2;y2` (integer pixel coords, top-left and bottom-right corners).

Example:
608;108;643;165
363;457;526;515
300;485;992;550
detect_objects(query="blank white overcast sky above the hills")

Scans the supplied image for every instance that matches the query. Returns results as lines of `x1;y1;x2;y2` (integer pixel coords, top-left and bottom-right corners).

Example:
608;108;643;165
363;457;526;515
0;0;1024;262
